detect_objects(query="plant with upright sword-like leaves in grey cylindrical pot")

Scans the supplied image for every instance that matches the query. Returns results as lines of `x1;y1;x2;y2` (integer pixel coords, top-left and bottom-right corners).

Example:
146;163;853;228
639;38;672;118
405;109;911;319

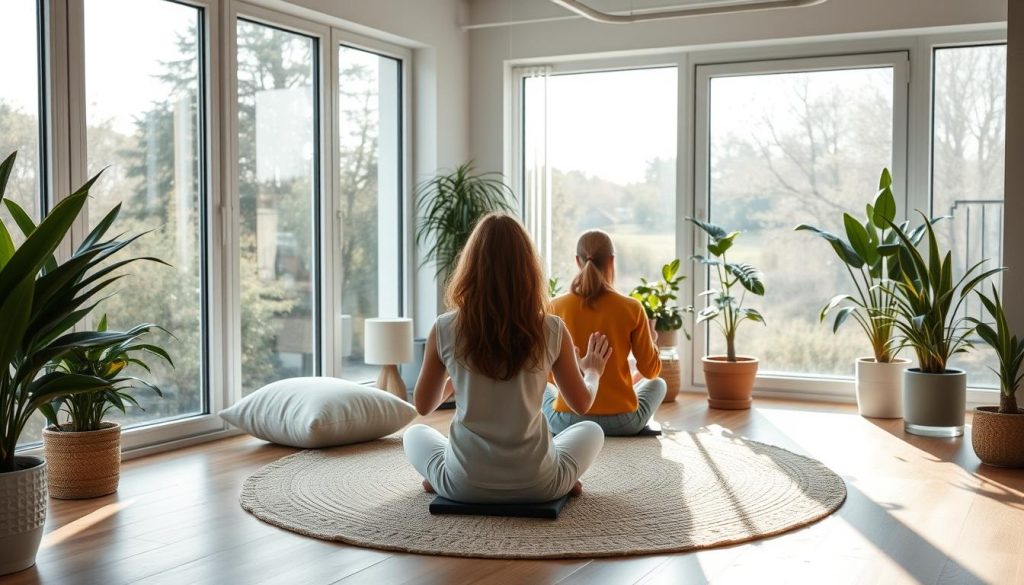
879;211;1004;436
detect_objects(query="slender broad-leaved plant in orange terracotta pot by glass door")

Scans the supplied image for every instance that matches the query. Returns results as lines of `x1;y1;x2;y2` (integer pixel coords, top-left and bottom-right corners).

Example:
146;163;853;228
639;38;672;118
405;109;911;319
687;217;765;410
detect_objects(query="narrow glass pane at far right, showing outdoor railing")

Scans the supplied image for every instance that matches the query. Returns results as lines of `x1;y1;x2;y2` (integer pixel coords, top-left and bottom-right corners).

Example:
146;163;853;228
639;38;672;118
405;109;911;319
932;45;1007;387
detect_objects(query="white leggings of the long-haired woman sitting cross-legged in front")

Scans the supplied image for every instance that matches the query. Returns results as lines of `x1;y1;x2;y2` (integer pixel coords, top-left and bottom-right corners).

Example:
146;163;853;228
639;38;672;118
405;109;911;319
402;421;604;504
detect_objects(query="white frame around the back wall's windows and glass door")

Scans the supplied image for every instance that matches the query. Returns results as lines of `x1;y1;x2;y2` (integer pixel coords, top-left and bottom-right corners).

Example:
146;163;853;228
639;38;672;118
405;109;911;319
503;24;1011;406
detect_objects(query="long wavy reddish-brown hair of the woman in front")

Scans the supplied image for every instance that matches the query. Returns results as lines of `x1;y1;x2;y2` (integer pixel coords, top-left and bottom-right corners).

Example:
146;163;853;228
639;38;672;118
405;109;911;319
445;213;548;380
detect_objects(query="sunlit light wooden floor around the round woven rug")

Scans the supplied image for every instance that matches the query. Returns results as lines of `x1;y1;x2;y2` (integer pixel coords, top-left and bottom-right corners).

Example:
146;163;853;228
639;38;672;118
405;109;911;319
0;394;1024;585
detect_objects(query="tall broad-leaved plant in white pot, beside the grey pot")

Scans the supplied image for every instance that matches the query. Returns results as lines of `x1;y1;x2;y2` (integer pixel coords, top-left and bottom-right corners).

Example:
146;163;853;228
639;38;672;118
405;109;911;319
796;169;924;418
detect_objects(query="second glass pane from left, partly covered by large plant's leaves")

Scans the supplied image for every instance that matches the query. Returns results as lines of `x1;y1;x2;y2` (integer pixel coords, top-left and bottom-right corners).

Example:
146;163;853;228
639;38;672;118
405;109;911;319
85;0;206;424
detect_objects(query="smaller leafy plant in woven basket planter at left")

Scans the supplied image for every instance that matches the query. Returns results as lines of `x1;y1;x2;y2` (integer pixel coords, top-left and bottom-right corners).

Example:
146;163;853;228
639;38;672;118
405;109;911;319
39;315;173;500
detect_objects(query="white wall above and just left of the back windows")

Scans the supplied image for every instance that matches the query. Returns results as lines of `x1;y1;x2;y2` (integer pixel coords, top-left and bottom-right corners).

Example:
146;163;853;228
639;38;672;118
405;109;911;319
467;0;1007;170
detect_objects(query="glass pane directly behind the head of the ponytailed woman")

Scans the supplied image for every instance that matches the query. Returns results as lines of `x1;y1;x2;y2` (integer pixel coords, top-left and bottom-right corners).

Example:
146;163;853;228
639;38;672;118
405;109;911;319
524;68;678;292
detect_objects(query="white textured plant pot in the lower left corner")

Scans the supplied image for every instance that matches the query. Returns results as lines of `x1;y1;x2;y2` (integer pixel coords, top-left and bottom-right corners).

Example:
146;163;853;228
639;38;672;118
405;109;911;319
0;457;46;575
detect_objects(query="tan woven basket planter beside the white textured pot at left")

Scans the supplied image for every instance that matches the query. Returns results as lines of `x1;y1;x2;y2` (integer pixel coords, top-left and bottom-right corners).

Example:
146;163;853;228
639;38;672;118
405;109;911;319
43;422;121;500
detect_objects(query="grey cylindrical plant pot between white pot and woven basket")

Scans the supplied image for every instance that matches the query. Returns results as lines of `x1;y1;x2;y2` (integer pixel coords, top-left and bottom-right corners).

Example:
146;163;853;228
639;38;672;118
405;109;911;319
903;368;967;436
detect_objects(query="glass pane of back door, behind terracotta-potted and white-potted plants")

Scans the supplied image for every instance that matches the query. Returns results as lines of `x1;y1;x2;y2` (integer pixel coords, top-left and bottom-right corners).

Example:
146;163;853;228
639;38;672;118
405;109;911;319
709;68;903;377
